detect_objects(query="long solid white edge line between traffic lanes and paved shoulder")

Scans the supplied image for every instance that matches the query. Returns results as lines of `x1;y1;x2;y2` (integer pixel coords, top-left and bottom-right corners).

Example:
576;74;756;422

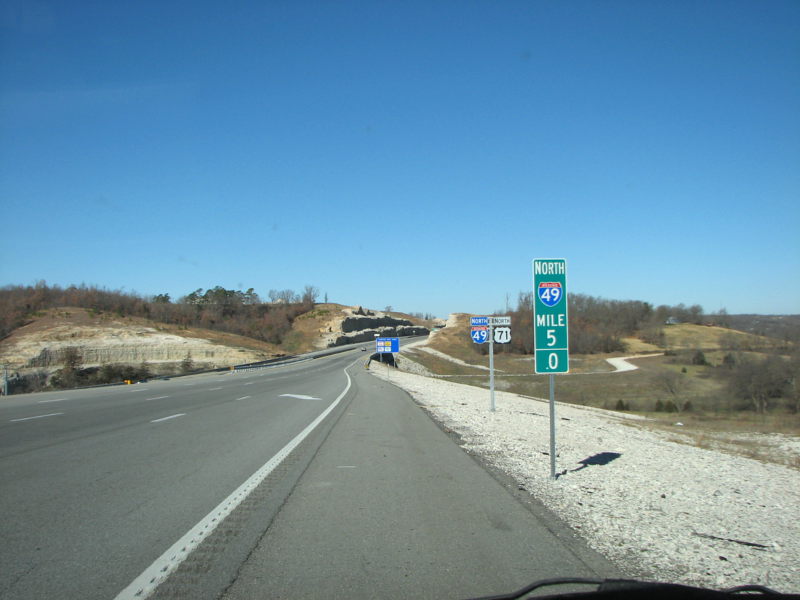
115;365;351;600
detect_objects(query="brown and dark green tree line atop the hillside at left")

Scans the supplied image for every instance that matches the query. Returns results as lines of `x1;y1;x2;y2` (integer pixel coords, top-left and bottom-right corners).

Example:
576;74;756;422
0;281;319;344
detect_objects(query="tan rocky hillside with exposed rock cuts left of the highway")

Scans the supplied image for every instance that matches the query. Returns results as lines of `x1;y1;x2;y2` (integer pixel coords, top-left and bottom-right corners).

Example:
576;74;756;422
0;304;430;384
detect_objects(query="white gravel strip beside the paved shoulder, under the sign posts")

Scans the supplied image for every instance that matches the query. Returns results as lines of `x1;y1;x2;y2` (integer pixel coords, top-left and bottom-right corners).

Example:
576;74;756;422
371;368;800;593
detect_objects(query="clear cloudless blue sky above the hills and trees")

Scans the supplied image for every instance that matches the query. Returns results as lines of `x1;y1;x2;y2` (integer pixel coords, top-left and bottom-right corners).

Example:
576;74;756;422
0;0;800;316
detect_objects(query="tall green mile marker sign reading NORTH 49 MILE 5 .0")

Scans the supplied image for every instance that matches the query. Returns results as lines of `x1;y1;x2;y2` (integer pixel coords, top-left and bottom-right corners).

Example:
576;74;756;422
533;258;569;374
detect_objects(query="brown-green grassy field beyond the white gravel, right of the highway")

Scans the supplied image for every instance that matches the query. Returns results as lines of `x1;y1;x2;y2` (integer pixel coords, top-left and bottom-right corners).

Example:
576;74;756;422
404;315;800;434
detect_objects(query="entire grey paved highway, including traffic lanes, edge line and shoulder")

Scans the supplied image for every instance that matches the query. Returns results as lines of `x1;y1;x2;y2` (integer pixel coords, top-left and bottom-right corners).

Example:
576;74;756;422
0;342;616;600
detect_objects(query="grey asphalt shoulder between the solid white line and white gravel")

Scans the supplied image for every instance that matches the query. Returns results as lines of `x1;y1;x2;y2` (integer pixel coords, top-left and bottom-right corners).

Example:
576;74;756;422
219;368;619;600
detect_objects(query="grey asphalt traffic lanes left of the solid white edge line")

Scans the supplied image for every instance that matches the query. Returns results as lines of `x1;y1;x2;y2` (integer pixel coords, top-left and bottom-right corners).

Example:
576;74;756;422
0;352;362;600
